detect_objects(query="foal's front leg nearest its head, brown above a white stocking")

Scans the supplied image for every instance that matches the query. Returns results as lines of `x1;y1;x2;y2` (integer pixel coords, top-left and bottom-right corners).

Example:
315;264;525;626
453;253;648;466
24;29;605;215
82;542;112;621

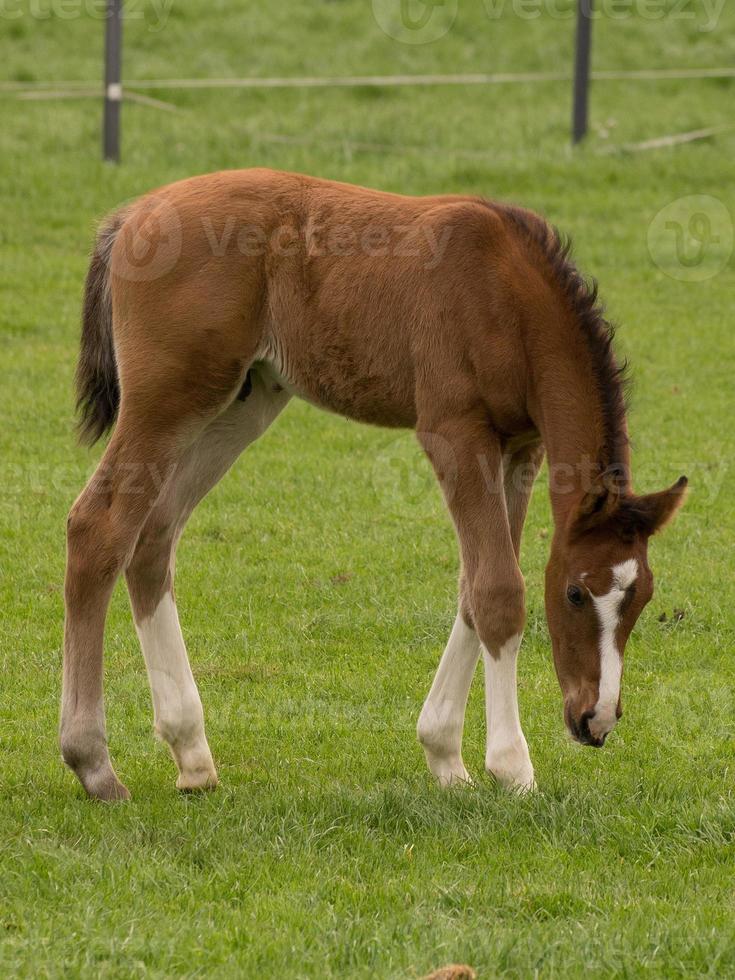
419;416;534;790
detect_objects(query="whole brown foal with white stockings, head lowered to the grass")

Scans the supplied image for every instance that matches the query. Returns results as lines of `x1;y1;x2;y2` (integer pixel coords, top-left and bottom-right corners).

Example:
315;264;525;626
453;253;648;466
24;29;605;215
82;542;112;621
60;169;687;801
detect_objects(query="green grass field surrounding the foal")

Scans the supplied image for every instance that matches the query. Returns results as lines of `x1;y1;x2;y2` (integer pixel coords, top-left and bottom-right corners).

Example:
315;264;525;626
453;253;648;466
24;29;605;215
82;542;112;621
0;0;735;978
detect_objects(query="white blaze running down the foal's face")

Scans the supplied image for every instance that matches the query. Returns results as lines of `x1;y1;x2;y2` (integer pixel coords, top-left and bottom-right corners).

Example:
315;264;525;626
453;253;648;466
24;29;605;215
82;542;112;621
589;558;638;738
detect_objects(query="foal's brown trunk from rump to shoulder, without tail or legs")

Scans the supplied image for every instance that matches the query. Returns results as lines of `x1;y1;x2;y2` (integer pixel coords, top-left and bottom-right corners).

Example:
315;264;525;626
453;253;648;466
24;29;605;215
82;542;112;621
108;170;540;427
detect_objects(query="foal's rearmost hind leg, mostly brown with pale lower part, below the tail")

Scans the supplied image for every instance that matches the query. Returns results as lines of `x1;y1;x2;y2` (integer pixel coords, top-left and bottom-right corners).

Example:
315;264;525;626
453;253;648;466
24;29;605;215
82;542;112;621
60;350;262;800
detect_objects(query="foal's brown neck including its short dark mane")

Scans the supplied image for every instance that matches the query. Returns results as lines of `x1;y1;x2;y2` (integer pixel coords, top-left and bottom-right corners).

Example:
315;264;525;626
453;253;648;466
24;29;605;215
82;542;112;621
492;205;630;528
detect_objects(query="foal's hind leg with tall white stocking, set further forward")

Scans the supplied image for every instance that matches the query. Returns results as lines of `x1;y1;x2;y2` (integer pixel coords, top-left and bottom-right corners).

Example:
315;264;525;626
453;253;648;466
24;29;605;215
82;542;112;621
126;372;289;790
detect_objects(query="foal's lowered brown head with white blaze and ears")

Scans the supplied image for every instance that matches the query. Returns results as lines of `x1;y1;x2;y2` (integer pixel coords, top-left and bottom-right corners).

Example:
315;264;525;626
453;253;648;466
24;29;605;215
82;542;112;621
546;472;687;747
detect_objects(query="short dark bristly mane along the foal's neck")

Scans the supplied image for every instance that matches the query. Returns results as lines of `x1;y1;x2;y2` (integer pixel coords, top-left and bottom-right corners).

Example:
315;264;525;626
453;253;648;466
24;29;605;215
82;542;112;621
493;205;630;476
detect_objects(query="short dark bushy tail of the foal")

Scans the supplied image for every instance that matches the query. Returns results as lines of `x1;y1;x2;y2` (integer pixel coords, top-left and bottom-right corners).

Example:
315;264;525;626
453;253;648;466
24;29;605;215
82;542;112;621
76;213;124;446
